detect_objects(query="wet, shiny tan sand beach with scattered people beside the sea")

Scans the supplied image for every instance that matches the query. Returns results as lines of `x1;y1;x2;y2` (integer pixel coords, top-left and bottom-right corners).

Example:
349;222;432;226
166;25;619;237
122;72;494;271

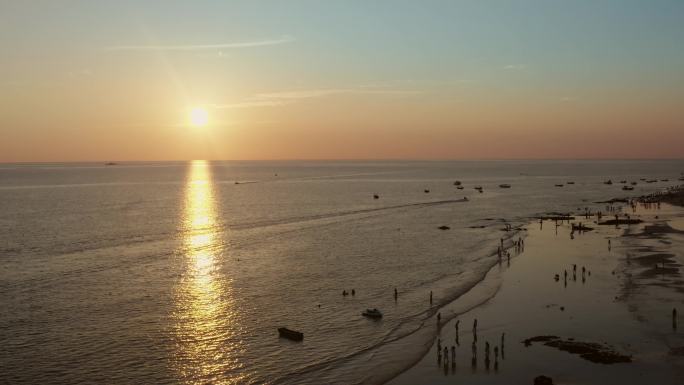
389;205;684;385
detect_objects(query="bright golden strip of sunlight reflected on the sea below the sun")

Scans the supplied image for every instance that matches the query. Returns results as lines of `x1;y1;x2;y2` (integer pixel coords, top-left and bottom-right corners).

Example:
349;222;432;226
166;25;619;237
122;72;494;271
174;161;246;384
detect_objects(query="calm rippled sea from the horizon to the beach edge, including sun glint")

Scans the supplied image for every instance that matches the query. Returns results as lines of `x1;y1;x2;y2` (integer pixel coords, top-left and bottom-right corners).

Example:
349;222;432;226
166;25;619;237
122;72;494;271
0;160;684;384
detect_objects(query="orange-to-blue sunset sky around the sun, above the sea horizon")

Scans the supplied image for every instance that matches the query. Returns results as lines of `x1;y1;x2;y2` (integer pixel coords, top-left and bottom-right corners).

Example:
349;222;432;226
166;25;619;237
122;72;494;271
0;0;684;162
